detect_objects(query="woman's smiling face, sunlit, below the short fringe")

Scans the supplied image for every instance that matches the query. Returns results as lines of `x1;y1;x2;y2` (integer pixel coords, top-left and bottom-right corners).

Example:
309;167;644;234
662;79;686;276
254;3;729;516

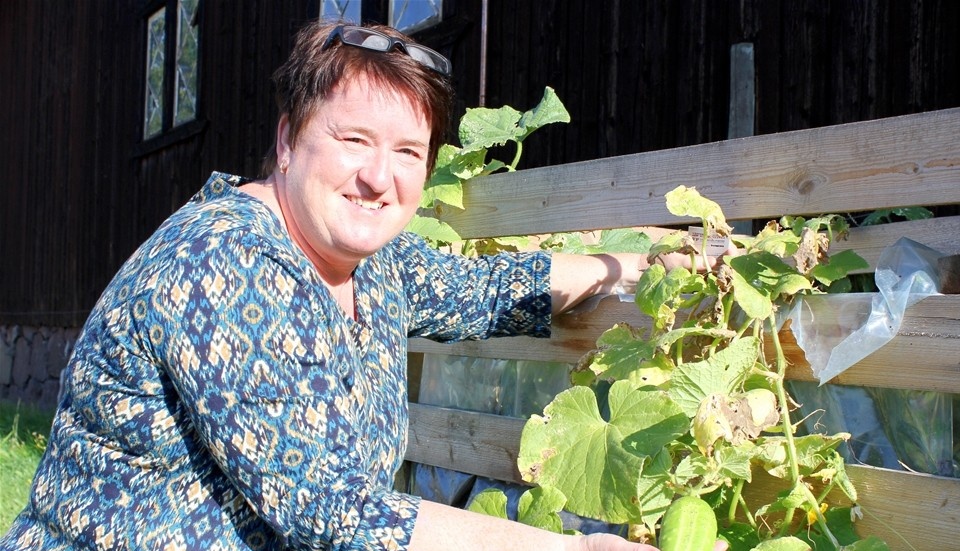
277;75;430;274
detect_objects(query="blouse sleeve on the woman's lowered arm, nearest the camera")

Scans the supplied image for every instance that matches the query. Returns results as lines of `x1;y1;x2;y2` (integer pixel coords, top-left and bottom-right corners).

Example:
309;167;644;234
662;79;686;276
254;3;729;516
148;231;419;549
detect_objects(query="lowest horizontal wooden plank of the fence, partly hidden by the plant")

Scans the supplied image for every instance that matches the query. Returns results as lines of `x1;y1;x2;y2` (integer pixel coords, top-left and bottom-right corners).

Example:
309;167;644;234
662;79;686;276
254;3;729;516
406;404;960;551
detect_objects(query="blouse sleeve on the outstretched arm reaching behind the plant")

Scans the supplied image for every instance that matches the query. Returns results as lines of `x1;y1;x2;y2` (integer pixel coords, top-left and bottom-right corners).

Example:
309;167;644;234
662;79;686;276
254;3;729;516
396;233;551;342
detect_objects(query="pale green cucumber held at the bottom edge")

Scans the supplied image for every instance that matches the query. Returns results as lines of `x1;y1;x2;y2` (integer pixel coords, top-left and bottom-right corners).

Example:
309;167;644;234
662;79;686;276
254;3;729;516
657;496;717;551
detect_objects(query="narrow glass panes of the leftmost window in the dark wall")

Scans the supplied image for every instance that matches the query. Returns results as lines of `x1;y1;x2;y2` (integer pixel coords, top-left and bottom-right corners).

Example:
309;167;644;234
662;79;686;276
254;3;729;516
143;0;200;139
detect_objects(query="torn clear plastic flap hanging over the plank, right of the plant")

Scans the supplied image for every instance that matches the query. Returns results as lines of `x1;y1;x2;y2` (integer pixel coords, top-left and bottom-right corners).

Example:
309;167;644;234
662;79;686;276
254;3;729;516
786;237;943;384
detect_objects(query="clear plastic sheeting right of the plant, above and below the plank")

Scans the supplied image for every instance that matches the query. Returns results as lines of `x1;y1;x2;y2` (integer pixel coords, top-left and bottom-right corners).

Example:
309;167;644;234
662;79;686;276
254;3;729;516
786;238;960;476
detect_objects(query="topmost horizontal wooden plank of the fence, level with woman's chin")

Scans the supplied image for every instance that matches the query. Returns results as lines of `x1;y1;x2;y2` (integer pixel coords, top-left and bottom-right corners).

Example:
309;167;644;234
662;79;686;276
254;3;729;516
438;108;960;237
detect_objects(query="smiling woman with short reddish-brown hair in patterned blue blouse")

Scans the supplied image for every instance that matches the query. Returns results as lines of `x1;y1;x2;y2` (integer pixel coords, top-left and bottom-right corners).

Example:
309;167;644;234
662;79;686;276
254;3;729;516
0;19;728;551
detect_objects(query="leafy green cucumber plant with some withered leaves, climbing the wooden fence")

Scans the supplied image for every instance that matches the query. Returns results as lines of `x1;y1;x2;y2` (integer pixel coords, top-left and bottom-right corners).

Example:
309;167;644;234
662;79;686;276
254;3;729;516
466;186;887;551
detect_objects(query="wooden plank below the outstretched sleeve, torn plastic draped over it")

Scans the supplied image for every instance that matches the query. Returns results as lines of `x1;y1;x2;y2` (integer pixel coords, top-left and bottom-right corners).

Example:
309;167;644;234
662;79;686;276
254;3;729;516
410;295;960;393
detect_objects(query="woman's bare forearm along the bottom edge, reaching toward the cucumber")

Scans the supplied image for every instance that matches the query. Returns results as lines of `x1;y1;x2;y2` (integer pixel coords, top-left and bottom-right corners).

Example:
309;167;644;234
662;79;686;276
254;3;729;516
409;500;656;551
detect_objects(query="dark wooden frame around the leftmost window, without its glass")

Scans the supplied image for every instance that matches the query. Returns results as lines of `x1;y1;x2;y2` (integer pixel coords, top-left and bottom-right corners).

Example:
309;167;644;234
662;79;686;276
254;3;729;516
134;0;207;156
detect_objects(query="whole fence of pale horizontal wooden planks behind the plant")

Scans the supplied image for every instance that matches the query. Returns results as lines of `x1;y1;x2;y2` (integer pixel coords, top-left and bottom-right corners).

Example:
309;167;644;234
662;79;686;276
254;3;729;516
407;109;960;551
